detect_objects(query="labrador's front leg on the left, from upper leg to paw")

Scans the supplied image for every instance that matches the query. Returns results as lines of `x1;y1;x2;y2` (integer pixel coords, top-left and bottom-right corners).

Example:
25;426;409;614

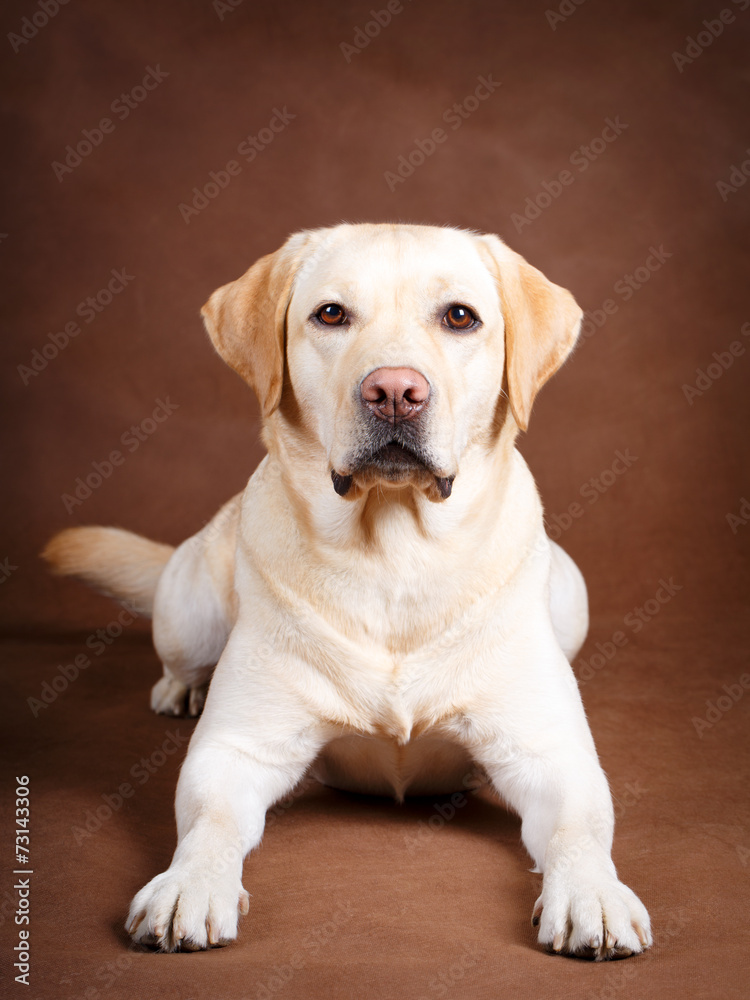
126;636;325;951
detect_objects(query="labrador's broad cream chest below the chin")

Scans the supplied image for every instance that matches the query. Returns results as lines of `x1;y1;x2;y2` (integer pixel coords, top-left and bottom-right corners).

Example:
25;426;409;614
240;464;544;744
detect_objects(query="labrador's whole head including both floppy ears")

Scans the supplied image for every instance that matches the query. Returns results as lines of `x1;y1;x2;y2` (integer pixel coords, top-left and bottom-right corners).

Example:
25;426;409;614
202;225;582;508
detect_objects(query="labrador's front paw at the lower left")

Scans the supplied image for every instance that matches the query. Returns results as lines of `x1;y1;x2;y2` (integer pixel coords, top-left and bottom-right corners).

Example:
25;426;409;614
125;867;250;951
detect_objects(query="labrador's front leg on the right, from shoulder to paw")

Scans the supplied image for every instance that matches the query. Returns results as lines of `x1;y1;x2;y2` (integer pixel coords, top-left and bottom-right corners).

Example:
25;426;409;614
462;651;652;959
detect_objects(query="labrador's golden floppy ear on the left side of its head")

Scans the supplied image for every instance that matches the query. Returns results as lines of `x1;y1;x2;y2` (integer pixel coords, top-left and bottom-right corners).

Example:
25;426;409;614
201;232;310;417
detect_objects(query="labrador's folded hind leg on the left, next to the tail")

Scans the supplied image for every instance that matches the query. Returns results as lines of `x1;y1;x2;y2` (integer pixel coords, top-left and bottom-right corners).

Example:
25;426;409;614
151;496;240;715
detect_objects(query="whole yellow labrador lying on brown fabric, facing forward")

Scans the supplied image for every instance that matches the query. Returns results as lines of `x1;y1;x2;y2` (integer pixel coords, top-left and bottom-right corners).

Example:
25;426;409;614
45;224;652;960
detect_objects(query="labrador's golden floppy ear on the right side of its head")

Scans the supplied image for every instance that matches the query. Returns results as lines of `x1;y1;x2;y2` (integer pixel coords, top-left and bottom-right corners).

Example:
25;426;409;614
479;235;583;431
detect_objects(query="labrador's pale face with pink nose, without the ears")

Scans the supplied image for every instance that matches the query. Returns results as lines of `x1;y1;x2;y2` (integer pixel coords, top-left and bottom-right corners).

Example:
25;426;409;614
287;226;504;496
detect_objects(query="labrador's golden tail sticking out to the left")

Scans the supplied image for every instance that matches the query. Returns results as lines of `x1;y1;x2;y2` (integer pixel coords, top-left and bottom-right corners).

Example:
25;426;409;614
42;527;174;615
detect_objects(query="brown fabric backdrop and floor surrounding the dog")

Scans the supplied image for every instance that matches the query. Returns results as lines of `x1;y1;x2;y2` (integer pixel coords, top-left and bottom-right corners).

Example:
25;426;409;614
0;0;750;1000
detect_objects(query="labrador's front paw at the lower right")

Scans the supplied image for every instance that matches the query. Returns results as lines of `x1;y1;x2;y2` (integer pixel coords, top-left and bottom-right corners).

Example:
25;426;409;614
531;871;653;962
